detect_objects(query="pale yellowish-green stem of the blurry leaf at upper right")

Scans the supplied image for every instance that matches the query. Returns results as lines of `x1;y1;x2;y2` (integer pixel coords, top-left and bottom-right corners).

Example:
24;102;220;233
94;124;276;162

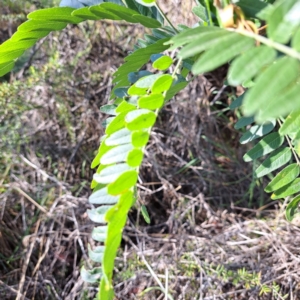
232;29;300;60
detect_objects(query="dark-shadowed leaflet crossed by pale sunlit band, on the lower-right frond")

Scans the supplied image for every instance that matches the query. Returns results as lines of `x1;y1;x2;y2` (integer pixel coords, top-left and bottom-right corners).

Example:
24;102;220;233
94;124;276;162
243;132;284;162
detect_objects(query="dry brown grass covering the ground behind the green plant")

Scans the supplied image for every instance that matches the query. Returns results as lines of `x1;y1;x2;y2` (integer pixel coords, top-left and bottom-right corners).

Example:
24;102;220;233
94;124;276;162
0;2;300;300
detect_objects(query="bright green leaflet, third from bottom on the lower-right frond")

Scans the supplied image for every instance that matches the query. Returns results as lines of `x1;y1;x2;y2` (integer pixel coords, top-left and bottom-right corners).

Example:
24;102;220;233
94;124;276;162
265;164;300;193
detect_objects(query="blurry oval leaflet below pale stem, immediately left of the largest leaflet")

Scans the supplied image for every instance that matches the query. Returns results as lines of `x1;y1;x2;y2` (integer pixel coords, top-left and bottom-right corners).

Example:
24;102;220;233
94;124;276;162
228;46;277;86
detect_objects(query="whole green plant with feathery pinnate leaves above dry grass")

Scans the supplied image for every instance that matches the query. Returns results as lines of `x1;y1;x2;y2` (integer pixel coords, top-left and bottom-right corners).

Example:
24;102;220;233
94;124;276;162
0;0;300;299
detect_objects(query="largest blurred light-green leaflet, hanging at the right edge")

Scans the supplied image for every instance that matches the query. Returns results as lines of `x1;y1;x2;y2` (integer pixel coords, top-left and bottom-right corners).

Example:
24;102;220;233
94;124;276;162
243;57;300;116
